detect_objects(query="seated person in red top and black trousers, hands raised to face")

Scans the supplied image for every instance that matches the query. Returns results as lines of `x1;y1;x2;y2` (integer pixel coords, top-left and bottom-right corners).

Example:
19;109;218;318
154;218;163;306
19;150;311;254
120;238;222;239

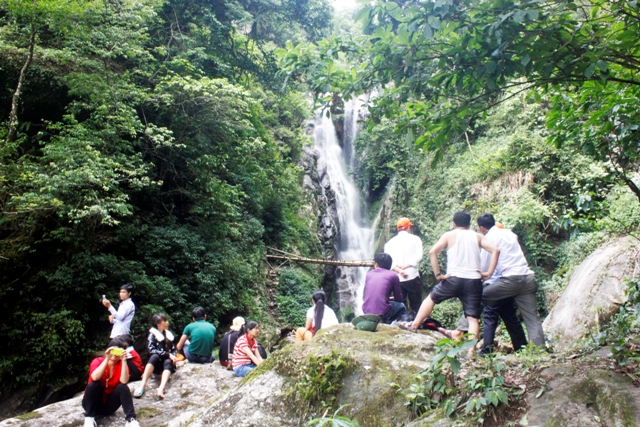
82;338;140;427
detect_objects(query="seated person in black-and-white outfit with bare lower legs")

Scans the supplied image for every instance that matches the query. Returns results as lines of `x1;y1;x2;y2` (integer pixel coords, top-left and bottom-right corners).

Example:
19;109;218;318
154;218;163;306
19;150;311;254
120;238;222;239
133;313;178;399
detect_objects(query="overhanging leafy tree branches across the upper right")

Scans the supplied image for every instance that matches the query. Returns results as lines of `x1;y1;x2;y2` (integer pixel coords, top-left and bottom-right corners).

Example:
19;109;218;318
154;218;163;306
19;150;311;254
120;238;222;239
279;0;640;197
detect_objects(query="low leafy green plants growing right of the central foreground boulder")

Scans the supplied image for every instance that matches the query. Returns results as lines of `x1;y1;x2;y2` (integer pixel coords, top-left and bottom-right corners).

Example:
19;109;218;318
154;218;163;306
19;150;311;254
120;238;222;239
400;339;513;424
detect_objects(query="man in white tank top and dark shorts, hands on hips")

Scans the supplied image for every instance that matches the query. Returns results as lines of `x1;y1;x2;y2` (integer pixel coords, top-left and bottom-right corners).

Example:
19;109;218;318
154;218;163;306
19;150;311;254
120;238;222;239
411;211;500;339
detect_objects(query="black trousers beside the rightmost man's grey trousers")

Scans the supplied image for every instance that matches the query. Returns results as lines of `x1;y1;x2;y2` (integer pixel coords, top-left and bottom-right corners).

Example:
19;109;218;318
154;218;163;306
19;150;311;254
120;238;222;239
480;298;527;354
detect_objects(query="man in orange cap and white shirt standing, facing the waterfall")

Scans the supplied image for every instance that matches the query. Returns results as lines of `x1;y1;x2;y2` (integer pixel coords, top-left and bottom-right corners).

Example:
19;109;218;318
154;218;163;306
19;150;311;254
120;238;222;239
384;218;423;312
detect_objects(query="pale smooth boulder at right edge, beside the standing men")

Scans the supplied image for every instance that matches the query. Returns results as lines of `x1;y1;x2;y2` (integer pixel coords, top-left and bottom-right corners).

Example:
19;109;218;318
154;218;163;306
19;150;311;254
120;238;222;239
543;237;639;349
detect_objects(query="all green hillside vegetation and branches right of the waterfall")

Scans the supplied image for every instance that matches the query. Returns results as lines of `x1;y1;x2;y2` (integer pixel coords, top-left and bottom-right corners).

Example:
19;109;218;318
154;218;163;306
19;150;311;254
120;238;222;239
278;0;640;326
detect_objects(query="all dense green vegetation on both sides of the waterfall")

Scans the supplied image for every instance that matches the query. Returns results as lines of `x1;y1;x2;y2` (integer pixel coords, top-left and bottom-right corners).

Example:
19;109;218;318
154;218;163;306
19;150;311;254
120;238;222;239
0;0;640;422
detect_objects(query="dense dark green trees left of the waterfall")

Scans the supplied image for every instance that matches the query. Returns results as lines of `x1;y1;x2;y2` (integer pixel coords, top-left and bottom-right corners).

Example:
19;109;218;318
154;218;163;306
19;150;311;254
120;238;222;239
0;0;332;412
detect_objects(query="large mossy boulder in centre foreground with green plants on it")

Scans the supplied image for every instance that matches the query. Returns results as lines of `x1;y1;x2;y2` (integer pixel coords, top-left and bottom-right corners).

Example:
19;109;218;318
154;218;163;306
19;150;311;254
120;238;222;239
192;325;441;427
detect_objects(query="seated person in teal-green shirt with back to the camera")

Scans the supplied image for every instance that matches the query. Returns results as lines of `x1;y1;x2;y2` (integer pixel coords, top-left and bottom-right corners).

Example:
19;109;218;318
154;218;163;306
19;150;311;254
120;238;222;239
177;307;216;363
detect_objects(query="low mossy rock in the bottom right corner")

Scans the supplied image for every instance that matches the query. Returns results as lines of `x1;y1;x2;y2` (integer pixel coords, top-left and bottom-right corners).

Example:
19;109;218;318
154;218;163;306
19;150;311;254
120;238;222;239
520;365;640;427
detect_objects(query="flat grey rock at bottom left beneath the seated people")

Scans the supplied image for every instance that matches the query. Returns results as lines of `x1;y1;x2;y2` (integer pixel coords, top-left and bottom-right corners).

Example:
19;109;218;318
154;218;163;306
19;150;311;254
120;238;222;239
0;362;239;427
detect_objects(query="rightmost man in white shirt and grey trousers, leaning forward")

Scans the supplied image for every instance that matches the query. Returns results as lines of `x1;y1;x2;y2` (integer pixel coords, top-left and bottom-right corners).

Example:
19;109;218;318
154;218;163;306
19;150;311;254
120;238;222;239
477;213;544;346
